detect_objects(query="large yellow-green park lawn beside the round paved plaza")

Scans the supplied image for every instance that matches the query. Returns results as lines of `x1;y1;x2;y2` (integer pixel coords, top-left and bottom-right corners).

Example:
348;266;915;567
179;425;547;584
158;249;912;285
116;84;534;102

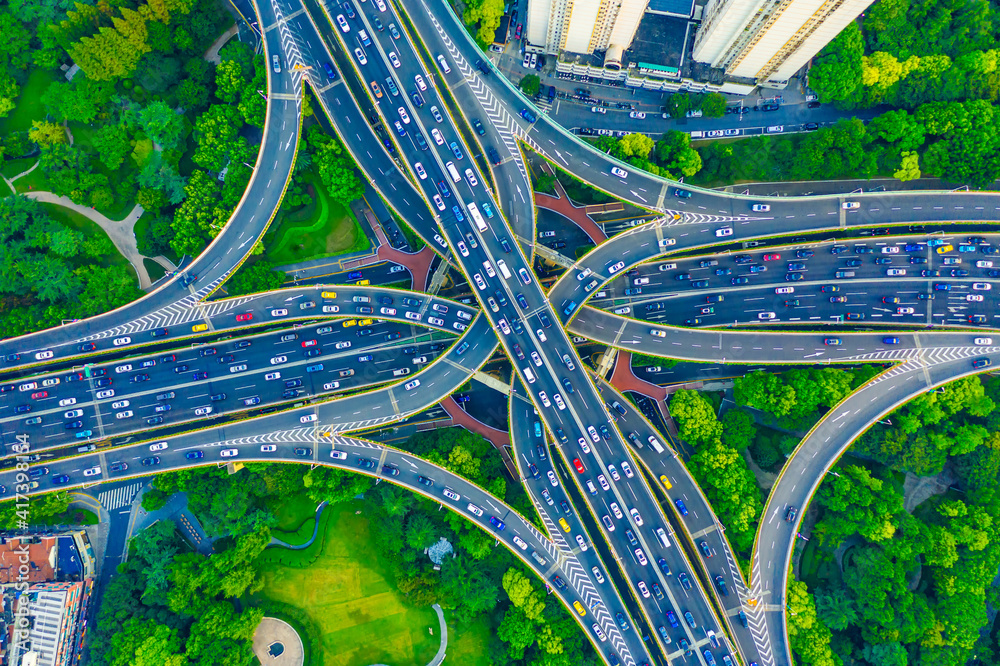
249;502;446;666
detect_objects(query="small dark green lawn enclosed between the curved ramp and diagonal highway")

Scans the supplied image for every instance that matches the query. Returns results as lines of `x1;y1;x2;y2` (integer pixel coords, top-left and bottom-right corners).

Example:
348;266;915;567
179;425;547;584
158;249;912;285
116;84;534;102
264;173;371;266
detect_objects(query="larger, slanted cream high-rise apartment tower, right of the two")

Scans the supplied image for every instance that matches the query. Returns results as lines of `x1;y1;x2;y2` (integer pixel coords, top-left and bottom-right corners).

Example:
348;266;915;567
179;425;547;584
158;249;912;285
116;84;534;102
693;0;873;86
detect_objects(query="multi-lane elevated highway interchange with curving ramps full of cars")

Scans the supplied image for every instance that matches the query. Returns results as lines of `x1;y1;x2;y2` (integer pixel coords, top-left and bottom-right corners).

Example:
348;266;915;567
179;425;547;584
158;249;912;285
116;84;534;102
0;0;1000;665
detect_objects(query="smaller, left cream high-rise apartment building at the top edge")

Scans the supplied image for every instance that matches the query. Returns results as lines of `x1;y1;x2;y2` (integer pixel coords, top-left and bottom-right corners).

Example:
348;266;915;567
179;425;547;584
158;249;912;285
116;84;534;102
527;0;649;59
